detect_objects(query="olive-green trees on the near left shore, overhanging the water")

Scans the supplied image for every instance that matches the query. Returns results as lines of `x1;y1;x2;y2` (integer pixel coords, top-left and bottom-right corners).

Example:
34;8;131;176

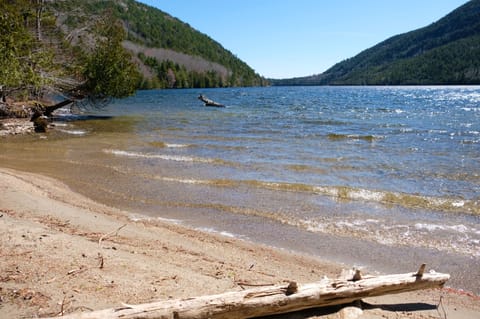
0;0;139;112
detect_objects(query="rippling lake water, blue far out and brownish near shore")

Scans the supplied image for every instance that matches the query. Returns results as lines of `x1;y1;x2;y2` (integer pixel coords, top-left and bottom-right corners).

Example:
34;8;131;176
0;87;480;293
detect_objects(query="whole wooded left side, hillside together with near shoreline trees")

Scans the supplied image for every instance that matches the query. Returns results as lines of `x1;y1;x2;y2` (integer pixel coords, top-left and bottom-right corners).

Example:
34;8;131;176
0;0;266;127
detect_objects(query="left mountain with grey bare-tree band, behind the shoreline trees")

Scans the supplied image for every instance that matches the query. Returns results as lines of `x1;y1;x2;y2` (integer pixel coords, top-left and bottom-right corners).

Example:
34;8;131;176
46;0;266;88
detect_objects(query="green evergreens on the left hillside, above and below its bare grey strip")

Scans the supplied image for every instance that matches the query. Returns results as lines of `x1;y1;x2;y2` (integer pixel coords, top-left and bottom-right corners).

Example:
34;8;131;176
51;0;266;88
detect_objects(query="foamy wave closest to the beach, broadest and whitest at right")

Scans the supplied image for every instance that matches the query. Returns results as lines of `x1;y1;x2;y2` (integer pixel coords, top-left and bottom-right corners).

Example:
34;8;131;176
129;186;480;257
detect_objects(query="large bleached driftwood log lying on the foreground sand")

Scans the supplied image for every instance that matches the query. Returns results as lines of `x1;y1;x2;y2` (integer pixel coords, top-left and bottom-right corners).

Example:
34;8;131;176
47;265;450;319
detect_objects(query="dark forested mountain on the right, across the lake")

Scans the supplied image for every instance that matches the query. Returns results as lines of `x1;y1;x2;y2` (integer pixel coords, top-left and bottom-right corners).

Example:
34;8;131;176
270;0;480;85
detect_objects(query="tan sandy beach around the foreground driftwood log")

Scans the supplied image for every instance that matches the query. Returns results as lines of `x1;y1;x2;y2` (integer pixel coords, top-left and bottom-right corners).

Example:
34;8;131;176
0;169;480;319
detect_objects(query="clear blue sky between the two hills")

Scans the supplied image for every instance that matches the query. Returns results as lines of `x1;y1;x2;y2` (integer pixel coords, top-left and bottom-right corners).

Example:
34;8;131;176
140;0;467;78
